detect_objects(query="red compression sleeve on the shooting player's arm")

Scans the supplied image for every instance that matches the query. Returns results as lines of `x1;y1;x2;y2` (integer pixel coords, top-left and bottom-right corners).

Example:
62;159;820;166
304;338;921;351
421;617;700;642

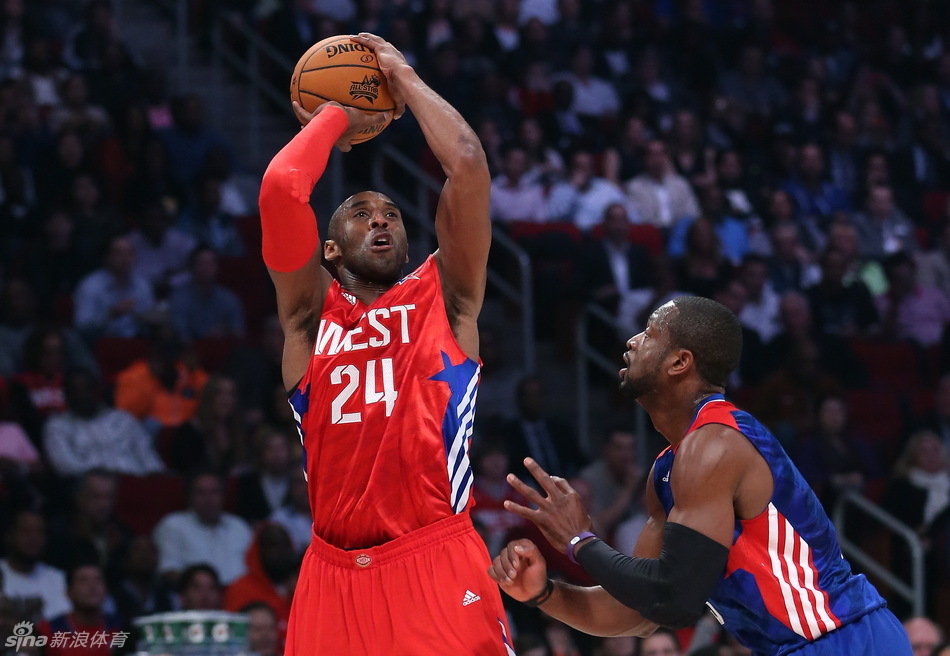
259;106;349;272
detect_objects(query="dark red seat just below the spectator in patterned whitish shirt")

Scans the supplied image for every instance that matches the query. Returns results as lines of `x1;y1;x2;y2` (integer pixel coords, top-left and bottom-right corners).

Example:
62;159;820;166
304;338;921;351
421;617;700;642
116;474;185;535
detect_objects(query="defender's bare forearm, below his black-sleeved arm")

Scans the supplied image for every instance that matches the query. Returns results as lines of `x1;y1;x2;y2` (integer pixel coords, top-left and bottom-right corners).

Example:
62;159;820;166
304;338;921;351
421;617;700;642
540;581;657;637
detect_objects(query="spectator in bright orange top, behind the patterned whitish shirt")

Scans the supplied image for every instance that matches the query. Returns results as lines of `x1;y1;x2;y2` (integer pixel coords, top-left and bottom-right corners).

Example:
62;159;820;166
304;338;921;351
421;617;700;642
115;329;208;432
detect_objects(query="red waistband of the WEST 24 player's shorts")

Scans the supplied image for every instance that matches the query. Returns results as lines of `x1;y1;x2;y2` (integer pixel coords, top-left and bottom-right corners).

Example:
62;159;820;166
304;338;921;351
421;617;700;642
310;512;475;569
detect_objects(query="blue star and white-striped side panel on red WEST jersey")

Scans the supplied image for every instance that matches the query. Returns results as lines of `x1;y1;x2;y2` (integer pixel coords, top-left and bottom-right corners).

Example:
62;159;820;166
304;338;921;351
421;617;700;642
429;351;480;513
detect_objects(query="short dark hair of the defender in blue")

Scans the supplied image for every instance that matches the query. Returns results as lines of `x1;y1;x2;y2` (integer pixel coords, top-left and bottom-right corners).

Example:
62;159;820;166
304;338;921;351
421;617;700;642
667;296;742;387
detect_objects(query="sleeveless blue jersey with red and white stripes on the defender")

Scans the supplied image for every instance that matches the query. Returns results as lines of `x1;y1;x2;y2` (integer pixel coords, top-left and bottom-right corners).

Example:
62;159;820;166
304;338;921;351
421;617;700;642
653;394;885;656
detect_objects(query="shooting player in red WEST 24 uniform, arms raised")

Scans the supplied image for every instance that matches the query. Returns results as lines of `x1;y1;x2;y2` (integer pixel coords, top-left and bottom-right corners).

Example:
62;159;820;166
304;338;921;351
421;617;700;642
260;33;513;656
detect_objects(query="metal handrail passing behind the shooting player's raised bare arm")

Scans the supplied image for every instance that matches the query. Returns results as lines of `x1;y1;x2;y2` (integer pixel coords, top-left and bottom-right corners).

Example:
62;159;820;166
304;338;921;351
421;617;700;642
373;144;536;372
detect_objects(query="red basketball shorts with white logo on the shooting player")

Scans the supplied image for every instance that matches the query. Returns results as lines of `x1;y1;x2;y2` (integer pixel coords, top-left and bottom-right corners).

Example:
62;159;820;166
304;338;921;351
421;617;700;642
284;513;514;656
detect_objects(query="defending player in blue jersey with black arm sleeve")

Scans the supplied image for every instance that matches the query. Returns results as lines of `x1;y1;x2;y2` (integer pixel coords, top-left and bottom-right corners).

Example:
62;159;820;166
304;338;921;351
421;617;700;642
490;297;911;656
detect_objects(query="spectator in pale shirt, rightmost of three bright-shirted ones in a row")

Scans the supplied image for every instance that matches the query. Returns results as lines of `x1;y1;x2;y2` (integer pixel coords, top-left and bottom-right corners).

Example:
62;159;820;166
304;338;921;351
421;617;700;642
624;139;700;228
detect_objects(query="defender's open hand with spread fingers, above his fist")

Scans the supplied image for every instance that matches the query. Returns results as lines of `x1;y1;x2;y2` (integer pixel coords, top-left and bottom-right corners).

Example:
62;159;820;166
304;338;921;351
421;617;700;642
505;458;593;553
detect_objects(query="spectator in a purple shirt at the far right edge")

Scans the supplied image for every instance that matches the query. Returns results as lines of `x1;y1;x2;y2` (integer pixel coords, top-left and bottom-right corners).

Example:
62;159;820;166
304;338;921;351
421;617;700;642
875;251;950;347
